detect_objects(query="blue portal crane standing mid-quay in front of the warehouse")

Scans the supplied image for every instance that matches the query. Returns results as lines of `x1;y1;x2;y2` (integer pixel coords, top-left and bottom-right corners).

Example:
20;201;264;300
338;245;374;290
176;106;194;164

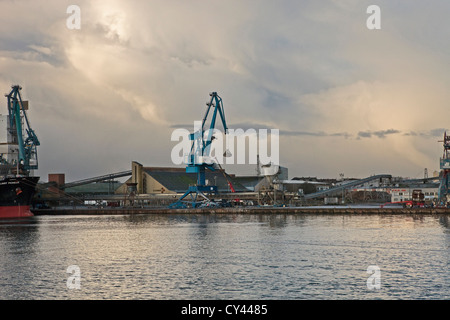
170;92;228;208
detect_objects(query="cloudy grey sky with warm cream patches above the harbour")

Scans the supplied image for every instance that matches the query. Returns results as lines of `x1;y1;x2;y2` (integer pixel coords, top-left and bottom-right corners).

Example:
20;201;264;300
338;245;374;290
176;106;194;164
0;0;450;181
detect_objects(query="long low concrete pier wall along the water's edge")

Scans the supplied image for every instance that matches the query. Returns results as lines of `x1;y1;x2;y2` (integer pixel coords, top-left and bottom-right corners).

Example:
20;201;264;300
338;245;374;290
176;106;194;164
32;207;450;216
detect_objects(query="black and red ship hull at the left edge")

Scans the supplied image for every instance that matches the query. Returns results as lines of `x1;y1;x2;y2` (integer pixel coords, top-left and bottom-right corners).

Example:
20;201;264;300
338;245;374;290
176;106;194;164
0;177;39;219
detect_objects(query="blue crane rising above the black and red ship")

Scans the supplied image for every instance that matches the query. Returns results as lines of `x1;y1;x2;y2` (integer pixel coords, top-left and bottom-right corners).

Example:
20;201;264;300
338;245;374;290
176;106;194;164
5;85;40;173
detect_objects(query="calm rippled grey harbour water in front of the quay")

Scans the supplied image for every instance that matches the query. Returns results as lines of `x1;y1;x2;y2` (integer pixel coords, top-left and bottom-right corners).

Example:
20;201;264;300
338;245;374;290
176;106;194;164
0;214;450;300
